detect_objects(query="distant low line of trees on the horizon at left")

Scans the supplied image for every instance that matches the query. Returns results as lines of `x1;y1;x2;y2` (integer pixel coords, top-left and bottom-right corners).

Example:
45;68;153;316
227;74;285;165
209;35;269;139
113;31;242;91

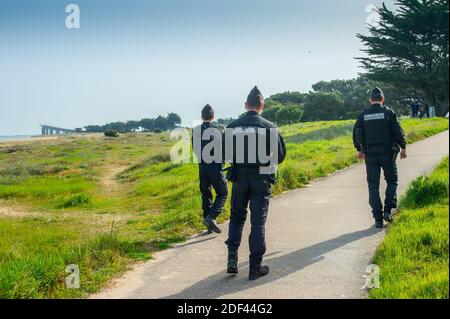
84;113;181;133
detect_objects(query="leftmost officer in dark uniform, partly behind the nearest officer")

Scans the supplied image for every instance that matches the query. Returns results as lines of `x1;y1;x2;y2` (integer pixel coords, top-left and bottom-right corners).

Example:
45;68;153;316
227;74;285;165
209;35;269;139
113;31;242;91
193;104;228;233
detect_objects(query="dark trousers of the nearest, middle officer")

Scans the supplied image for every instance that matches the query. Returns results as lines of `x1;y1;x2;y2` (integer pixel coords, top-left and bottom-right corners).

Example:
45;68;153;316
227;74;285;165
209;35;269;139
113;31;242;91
226;174;272;269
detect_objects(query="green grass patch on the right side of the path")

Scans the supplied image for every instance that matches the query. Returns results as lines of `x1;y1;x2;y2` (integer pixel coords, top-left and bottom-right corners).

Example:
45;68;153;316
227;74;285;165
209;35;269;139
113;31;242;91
370;158;449;299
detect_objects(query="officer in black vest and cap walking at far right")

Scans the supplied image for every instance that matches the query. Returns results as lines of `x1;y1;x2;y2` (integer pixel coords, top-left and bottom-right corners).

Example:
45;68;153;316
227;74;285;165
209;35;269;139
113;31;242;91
353;88;407;228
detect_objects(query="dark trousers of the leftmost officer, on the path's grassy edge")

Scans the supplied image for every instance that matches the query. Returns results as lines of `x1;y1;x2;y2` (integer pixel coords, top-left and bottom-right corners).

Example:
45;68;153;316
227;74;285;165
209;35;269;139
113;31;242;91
199;165;228;219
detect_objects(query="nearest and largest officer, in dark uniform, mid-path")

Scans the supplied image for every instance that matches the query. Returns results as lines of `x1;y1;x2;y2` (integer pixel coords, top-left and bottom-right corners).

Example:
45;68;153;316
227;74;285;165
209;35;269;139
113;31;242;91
225;87;286;280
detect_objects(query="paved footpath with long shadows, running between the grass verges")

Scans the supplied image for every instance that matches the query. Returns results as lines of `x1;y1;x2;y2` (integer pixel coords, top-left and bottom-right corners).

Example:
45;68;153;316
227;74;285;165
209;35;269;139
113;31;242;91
92;131;449;299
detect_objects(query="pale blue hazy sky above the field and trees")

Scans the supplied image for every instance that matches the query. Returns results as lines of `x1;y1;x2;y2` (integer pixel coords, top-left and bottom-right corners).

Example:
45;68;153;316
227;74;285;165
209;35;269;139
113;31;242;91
0;0;392;135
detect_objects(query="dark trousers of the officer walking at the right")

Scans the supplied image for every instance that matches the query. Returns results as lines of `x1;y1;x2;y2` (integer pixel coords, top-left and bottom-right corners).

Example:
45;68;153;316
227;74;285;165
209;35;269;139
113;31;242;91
366;151;398;219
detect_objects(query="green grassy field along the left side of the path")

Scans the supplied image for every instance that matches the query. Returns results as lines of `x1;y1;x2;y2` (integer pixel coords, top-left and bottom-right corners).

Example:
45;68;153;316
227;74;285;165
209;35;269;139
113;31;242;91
0;119;448;298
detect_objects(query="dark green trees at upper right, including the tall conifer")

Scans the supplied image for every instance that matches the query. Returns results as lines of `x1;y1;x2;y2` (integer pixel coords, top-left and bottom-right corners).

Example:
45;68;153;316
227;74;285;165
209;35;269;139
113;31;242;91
263;0;449;125
